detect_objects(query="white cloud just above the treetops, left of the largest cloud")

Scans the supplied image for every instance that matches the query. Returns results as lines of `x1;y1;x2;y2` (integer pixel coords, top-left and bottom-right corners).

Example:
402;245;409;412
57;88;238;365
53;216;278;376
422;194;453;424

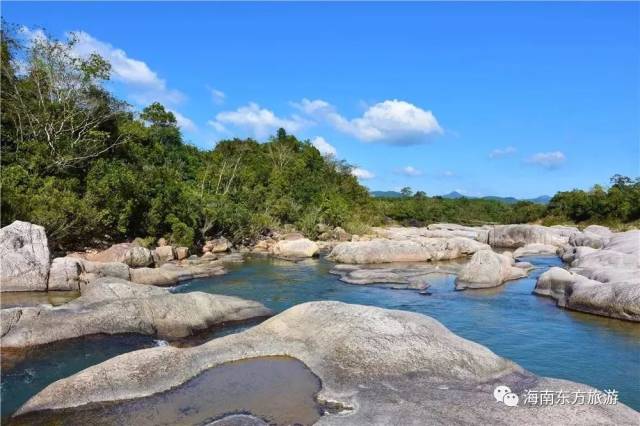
209;102;308;139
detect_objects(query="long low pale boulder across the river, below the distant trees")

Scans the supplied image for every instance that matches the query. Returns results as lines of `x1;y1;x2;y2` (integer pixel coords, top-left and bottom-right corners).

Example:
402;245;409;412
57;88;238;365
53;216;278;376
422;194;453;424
329;237;489;264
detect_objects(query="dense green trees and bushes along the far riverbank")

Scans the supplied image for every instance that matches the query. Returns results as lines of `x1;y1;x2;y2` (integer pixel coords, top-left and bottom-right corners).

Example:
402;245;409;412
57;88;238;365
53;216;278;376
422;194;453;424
1;25;640;250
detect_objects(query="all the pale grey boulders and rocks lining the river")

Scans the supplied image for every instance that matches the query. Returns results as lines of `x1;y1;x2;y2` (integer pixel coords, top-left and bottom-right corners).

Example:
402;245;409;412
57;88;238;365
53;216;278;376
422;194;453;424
0;222;640;424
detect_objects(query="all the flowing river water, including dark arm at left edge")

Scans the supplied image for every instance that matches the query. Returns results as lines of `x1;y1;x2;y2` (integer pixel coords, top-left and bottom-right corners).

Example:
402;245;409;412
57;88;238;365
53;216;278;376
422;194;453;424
2;253;640;418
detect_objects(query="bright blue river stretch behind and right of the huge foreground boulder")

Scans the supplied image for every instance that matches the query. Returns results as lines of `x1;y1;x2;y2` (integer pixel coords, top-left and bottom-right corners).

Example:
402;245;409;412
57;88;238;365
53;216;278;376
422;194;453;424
175;256;640;410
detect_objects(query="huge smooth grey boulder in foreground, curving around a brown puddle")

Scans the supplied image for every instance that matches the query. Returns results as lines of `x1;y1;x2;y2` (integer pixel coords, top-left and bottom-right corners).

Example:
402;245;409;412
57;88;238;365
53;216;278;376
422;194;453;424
16;302;640;425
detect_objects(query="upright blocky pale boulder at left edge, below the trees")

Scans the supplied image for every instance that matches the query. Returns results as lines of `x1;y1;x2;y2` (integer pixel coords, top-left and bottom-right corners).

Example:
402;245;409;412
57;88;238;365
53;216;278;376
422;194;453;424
0;221;49;291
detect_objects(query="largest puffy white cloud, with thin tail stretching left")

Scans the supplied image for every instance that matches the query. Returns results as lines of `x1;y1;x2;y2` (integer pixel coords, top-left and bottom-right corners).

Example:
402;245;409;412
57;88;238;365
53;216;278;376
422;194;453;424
293;99;442;145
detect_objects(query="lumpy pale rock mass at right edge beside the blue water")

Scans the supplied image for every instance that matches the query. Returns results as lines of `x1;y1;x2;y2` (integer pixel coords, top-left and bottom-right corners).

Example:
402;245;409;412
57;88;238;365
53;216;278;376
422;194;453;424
534;231;640;322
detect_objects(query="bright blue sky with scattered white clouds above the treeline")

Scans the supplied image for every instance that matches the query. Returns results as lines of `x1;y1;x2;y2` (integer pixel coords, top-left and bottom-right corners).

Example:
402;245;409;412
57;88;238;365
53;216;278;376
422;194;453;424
2;2;640;198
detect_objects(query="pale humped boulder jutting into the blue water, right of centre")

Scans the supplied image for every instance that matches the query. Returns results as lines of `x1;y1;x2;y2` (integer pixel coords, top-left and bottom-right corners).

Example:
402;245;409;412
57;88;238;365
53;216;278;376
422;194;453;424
456;250;528;290
